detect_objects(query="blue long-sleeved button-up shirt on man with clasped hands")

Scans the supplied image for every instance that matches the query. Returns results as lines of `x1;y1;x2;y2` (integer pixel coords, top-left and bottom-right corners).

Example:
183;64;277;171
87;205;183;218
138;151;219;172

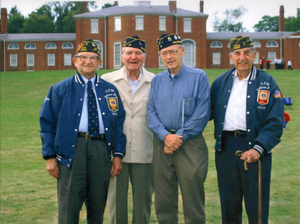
148;64;210;141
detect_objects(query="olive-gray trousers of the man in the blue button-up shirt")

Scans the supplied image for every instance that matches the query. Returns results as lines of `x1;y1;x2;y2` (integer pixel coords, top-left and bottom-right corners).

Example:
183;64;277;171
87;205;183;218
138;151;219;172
153;135;208;224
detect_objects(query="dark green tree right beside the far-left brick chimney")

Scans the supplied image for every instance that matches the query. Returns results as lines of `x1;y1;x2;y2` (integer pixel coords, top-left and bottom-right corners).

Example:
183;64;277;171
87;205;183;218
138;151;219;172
7;6;25;33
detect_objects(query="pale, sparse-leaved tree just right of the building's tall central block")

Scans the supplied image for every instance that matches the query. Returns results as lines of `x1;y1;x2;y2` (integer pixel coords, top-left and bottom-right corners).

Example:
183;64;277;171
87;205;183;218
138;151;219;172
213;6;248;32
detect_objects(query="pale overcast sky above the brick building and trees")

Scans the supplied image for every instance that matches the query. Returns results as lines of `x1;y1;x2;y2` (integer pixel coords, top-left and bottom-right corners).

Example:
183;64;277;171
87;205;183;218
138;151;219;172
0;0;300;32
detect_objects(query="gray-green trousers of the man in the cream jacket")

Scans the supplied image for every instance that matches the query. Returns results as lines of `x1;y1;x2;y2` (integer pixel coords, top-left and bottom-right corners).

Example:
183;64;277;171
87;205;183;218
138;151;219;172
108;163;153;224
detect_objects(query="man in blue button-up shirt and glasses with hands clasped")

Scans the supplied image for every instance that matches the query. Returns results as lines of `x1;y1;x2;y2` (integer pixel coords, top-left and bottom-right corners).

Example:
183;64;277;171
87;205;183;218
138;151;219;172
148;34;210;224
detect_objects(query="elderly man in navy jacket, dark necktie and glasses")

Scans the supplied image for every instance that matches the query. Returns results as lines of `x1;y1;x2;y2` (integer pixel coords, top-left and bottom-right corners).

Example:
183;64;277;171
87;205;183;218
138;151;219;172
40;39;126;224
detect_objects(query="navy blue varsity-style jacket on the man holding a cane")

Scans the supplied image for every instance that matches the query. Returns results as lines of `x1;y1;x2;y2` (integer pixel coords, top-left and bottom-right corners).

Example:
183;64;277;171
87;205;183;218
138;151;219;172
211;66;284;154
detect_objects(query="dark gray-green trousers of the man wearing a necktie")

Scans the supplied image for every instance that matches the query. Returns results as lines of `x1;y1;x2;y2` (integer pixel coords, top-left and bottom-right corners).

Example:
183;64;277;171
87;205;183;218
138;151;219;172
57;138;111;224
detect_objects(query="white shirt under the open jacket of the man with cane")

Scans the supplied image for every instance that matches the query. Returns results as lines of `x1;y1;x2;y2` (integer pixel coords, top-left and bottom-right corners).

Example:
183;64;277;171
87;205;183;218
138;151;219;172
223;71;250;131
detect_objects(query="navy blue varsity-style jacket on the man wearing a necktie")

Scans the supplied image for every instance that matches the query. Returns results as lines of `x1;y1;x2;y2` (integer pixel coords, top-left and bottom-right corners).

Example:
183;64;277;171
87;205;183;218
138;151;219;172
40;74;126;168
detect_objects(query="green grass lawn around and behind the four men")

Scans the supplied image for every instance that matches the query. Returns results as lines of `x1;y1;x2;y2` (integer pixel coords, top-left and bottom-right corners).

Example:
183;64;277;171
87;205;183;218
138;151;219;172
0;69;300;224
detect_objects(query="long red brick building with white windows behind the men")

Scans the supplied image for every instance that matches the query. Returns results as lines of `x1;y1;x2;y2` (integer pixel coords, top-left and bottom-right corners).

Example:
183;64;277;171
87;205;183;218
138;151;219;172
0;1;300;71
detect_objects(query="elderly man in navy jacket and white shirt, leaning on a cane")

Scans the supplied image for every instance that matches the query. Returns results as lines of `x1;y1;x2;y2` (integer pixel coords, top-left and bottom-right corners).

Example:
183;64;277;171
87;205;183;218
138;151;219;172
211;36;284;223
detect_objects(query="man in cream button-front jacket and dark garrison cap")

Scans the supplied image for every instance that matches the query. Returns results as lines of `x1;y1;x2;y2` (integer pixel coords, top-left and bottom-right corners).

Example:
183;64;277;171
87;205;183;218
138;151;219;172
101;36;154;224
